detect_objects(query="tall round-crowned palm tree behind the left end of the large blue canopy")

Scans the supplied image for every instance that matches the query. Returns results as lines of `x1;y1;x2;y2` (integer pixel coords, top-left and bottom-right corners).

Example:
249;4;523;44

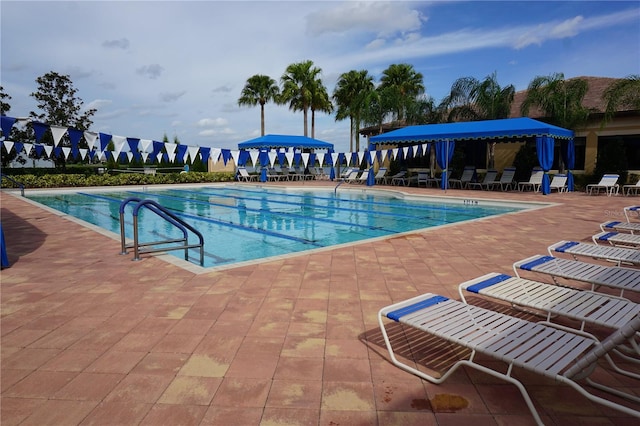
380;64;425;121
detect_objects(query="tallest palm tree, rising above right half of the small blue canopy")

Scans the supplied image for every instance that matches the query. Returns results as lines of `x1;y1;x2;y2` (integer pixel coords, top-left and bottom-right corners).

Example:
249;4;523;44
279;60;321;136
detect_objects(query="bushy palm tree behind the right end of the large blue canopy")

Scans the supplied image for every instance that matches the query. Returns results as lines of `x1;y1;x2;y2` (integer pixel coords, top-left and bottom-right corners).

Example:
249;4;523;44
521;73;589;130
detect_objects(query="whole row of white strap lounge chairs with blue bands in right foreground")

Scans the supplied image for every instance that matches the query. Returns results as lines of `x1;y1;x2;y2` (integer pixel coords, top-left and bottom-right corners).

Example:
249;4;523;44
378;206;640;424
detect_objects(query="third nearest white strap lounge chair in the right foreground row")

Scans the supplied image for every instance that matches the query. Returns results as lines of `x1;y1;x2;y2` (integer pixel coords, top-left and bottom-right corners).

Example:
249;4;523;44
513;255;640;297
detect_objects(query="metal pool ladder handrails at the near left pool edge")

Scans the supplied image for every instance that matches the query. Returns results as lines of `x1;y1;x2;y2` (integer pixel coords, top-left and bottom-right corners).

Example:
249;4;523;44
120;197;204;266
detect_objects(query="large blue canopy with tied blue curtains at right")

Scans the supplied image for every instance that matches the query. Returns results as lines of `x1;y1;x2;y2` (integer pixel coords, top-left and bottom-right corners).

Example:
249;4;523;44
369;117;575;194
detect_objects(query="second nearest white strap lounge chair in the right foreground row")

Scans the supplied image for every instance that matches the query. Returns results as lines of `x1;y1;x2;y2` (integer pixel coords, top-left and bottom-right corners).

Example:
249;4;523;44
458;272;640;360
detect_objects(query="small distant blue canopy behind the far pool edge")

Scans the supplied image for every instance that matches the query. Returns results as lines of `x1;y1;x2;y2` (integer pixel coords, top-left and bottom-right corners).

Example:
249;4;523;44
238;135;334;181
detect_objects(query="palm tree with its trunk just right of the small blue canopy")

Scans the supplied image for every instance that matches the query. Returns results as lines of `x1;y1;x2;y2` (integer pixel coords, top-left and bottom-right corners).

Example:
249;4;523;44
333;70;374;151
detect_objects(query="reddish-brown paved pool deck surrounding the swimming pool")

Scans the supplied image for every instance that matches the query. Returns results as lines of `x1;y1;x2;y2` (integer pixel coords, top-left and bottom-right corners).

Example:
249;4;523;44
0;182;640;426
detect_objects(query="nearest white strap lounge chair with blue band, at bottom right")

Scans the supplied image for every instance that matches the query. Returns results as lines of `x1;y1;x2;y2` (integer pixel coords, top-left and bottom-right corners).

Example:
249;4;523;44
378;293;640;425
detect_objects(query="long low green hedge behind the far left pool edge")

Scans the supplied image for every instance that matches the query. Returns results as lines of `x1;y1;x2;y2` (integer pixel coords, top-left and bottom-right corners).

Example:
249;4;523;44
2;172;235;188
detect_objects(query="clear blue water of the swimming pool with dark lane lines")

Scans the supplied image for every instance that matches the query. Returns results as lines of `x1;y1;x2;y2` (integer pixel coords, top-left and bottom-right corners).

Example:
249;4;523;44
29;186;525;267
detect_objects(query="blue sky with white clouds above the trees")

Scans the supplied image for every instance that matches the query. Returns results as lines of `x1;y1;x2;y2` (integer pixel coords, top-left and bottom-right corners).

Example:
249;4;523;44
0;0;640;152
